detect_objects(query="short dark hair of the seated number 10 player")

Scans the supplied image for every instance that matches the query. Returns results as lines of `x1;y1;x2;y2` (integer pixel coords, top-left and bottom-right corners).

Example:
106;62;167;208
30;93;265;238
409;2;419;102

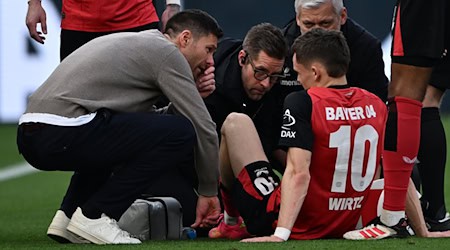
292;29;350;77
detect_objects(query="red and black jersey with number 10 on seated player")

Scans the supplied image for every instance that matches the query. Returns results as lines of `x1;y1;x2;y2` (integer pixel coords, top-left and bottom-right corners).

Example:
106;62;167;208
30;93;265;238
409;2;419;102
275;87;387;239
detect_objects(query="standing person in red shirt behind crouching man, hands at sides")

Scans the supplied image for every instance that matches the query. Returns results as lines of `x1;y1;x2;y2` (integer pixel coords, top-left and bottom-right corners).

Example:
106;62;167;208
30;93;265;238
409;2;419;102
26;0;180;61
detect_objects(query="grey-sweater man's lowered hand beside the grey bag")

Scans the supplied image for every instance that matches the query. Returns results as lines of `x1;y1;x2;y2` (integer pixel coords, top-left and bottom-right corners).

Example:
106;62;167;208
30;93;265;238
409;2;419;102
191;195;221;228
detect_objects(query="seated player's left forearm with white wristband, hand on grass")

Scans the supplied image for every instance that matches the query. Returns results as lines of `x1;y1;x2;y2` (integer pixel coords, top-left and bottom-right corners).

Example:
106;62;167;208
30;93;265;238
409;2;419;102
243;148;311;242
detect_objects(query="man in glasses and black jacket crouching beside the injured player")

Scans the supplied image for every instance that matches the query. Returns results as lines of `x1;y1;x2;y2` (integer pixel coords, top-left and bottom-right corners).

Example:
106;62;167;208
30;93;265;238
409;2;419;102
205;23;288;157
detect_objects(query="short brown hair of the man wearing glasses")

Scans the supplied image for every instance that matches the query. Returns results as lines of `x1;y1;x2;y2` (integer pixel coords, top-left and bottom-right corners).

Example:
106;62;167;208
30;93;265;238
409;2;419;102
242;23;289;59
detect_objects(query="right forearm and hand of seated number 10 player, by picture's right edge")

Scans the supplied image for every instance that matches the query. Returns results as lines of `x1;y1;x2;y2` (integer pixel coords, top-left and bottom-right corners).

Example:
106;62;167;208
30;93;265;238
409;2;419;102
406;179;450;238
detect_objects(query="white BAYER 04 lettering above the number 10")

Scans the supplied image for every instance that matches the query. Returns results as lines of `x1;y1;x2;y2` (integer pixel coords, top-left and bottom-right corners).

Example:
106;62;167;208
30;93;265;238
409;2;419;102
325;105;377;121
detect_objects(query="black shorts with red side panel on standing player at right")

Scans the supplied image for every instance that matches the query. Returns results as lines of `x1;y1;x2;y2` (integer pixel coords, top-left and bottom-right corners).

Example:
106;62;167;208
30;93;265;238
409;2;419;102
391;0;450;67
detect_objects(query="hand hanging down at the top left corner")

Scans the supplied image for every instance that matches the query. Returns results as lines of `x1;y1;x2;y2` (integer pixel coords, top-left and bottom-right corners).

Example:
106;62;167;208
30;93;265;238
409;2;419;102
25;0;47;44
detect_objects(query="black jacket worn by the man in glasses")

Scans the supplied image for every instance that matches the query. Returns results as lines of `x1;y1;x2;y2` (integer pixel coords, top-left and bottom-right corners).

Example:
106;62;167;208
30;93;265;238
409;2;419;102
205;38;279;156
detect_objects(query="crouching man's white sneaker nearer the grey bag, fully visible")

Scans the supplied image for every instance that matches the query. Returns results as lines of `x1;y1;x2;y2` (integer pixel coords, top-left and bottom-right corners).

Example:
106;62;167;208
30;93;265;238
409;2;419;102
67;208;141;245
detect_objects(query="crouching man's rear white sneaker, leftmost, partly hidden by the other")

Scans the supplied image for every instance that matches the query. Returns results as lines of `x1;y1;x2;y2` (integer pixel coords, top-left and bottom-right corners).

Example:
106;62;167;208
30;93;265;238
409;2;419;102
47;210;91;244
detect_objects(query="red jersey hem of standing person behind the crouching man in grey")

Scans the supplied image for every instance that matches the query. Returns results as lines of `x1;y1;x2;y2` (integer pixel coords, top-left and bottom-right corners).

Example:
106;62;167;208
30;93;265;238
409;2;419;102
61;0;159;32
